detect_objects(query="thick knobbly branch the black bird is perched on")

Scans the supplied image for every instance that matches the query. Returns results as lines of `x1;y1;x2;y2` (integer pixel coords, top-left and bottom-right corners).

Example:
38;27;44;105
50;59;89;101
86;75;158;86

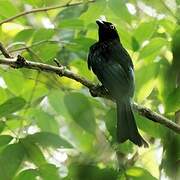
0;43;180;134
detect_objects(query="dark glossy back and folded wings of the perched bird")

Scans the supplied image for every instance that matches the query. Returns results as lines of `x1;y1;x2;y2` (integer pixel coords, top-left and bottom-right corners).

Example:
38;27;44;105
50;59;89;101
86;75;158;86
89;41;134;98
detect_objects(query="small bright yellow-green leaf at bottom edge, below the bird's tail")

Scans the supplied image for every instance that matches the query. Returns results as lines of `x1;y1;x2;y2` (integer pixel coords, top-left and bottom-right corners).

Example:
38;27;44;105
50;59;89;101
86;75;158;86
126;167;157;180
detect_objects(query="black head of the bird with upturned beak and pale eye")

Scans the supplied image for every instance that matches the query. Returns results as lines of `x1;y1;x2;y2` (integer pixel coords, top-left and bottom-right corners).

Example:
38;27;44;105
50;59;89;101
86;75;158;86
96;19;119;42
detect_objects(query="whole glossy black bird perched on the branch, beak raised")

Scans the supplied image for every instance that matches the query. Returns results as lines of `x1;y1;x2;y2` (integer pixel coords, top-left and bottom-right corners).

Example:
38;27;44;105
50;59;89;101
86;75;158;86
88;20;148;147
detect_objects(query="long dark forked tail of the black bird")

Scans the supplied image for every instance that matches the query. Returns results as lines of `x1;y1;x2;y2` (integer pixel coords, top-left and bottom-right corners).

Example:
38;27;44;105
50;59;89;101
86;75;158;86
116;100;148;147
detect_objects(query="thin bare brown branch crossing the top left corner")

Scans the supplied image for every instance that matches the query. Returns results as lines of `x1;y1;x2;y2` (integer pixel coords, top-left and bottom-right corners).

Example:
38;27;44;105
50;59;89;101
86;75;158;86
0;0;95;25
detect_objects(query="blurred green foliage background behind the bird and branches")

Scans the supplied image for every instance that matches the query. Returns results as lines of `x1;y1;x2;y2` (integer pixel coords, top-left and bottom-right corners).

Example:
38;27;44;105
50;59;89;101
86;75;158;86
0;0;180;180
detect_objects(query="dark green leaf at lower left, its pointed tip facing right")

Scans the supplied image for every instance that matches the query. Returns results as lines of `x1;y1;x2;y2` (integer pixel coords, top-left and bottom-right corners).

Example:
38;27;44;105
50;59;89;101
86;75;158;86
27;132;72;148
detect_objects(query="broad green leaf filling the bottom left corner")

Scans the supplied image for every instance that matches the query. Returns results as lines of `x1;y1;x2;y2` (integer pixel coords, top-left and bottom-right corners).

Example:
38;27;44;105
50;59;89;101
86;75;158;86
0;143;25;180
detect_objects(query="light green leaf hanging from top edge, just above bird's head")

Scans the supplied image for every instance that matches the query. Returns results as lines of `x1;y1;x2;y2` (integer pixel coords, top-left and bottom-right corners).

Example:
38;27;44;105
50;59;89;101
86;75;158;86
108;0;131;22
